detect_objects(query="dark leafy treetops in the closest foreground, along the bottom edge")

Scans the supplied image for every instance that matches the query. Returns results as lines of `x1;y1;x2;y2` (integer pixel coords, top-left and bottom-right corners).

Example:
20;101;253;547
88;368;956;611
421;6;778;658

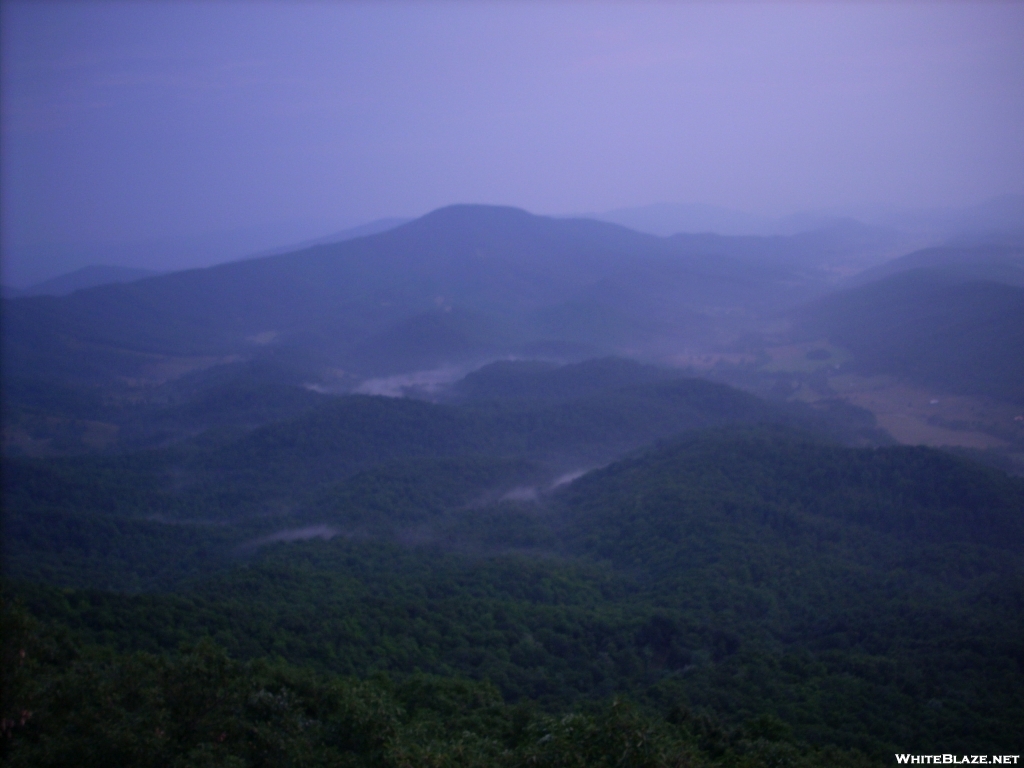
0;593;884;768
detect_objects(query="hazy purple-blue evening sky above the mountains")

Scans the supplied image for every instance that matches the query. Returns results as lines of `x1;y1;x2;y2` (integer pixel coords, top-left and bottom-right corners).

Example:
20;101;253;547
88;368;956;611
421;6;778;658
0;0;1024;284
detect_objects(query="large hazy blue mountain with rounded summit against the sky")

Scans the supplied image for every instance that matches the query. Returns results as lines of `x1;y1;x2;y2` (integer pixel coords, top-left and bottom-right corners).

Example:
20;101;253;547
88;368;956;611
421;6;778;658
4;206;849;391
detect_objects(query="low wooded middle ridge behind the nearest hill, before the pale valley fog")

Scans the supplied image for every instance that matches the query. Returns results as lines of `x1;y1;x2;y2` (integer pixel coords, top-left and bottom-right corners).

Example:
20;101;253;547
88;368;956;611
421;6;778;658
4;359;877;589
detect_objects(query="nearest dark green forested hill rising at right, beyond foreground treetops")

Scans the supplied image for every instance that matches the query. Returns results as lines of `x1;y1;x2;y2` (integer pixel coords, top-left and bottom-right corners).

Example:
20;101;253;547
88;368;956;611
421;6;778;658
4;428;1024;759
